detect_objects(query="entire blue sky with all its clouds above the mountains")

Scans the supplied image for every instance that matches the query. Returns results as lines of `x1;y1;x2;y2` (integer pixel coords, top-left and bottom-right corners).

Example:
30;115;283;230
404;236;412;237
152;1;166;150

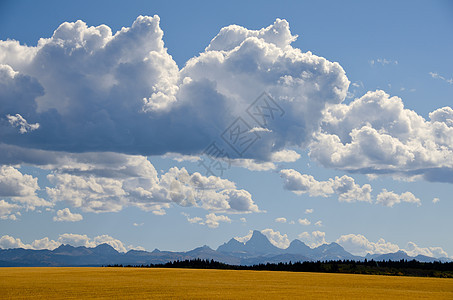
0;1;453;257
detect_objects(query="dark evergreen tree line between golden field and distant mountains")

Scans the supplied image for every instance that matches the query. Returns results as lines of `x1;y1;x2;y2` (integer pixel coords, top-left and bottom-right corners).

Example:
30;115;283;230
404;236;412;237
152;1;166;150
107;258;453;278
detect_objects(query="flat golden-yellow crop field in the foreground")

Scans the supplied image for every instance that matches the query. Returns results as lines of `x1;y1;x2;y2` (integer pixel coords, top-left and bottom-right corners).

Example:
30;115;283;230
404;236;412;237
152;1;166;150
0;268;453;299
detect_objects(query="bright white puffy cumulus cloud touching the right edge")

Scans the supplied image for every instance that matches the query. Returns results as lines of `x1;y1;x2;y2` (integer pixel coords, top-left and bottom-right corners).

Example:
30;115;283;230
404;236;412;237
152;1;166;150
310;91;453;182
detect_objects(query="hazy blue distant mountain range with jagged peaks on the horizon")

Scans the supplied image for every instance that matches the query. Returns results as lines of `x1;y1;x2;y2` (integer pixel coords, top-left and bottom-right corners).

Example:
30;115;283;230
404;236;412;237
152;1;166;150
0;230;451;267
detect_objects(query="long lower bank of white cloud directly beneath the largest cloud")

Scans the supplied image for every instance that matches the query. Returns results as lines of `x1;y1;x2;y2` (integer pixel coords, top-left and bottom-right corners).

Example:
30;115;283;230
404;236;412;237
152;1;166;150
0;149;260;216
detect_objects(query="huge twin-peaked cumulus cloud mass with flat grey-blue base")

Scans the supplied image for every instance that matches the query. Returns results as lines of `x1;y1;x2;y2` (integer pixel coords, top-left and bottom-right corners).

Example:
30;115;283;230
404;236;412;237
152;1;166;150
0;16;349;161
